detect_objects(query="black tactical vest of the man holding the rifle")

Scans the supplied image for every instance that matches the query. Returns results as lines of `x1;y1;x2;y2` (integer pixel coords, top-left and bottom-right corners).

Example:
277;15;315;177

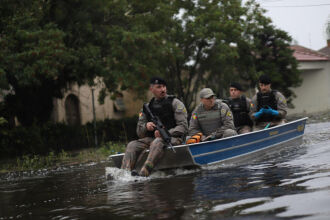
146;96;176;137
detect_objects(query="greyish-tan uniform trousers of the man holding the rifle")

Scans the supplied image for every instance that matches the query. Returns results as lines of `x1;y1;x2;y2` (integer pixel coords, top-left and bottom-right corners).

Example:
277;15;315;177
121;137;182;170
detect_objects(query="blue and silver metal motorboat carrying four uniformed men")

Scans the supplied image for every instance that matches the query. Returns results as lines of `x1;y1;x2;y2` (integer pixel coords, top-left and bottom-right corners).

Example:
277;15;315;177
109;118;308;170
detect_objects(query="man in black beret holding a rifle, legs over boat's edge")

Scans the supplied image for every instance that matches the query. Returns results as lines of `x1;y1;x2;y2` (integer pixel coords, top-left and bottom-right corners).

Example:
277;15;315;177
121;77;188;176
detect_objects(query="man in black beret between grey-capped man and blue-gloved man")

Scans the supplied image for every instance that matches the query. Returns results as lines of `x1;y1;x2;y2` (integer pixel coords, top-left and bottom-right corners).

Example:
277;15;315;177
224;82;253;134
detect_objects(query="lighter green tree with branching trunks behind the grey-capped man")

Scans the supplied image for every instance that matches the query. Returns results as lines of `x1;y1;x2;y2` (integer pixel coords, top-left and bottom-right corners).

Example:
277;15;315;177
154;0;244;111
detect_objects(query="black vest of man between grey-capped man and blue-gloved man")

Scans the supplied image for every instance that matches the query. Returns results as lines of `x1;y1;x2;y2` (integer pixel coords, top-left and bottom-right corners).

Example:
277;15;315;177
228;95;253;128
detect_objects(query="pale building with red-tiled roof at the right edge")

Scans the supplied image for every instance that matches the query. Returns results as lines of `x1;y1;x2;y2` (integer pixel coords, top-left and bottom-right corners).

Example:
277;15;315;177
288;45;330;115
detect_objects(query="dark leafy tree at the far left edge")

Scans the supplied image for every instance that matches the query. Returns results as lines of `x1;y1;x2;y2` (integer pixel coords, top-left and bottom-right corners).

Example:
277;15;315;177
0;1;75;125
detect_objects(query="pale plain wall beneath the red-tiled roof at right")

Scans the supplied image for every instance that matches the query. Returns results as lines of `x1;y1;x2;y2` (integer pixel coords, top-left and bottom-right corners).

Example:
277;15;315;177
288;61;330;115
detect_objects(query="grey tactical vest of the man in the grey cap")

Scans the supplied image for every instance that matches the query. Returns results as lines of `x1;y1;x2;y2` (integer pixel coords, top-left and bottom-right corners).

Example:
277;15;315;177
196;102;223;136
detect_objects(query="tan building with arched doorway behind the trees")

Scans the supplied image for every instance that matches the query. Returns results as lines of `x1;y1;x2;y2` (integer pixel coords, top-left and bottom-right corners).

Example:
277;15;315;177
52;85;142;125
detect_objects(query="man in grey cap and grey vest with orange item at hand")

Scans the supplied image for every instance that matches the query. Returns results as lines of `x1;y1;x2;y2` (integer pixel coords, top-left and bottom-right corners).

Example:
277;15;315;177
186;88;237;144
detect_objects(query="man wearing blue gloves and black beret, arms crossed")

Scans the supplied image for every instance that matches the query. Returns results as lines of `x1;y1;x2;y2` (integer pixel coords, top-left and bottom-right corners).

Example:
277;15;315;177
250;75;287;131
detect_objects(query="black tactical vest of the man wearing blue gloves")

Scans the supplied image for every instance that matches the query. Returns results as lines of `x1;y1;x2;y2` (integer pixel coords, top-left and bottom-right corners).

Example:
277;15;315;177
257;90;277;122
